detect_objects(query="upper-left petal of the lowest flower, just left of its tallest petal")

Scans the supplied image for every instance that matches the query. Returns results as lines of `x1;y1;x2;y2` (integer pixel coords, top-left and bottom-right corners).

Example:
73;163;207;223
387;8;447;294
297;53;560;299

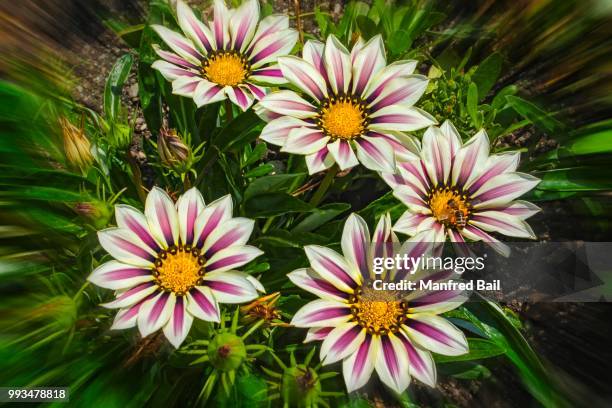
304;245;362;293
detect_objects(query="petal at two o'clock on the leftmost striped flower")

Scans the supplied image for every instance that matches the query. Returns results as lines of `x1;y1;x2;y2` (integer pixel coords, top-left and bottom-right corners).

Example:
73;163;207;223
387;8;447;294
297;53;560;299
202;217;255;259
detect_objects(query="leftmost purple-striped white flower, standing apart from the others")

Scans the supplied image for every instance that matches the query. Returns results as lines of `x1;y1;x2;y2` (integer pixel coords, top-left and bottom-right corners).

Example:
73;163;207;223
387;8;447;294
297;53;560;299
88;187;263;348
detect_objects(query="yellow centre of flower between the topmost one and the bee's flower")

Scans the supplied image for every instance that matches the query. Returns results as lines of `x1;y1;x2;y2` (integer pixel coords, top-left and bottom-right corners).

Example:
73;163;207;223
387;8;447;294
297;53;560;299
318;96;366;140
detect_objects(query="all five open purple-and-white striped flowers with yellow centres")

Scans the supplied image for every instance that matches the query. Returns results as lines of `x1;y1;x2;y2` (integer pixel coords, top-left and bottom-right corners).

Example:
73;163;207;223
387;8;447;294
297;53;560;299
89;0;539;392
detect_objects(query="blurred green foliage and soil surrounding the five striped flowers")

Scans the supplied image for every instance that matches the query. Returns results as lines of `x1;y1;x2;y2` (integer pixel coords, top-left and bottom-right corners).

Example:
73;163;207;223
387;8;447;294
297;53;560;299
0;0;612;406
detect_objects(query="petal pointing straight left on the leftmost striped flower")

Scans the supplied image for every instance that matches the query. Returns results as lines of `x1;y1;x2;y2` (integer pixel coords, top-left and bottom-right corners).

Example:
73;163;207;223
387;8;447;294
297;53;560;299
87;261;153;290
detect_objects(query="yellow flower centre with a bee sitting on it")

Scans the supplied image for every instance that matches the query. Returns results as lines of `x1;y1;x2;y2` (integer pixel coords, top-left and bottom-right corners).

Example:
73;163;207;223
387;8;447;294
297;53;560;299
429;187;471;229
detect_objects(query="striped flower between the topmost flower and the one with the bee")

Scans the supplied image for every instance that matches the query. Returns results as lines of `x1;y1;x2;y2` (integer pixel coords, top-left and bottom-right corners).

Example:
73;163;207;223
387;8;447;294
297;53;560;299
256;35;435;174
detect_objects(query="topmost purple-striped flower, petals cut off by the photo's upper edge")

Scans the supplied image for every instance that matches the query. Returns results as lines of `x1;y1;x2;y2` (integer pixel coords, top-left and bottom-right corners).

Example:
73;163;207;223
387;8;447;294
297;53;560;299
153;0;297;110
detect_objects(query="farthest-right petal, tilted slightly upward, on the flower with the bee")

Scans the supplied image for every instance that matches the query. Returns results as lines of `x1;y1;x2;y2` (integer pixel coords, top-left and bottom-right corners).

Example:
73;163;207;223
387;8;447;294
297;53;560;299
472;173;540;209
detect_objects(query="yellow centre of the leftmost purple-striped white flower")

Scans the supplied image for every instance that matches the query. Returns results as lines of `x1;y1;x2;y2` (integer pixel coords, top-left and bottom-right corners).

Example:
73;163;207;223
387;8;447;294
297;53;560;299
153;246;204;296
